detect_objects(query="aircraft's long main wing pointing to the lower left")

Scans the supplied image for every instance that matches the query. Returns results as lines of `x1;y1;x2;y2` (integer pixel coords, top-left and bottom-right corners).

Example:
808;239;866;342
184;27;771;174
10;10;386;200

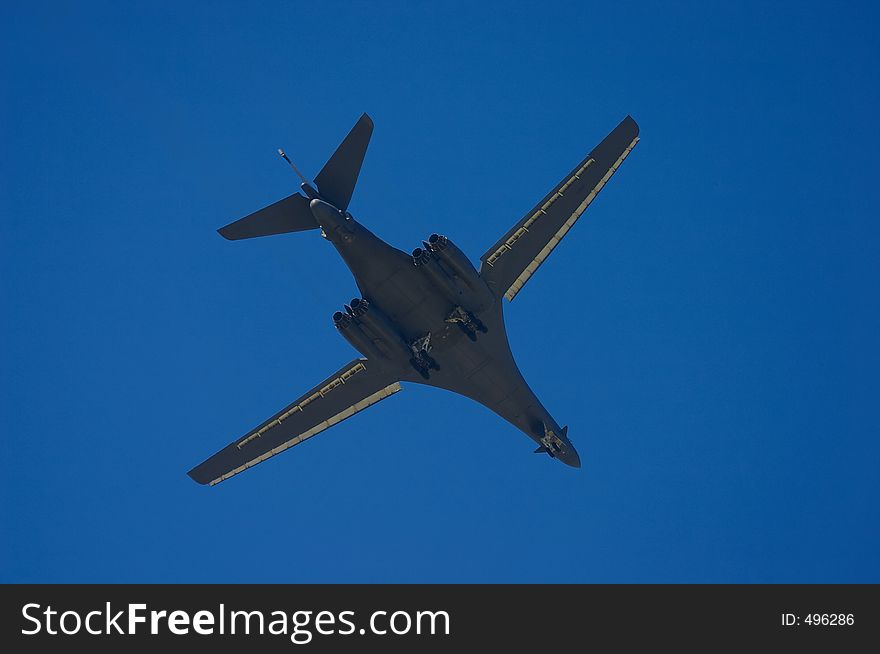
187;359;401;486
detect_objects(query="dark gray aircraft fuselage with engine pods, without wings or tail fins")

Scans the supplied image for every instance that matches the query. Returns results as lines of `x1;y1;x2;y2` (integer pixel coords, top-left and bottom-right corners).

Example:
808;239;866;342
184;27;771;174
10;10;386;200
310;199;580;467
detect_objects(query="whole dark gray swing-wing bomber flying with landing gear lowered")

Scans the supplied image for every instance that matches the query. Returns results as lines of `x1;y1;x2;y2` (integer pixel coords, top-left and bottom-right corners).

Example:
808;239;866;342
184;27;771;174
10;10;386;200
189;114;639;485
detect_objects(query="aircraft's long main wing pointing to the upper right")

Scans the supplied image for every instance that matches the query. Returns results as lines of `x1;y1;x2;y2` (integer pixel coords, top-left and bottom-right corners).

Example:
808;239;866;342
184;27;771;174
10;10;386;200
480;116;639;300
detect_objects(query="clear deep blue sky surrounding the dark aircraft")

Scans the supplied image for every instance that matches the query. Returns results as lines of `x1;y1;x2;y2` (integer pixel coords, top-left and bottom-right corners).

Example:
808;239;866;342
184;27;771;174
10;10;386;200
0;2;880;582
